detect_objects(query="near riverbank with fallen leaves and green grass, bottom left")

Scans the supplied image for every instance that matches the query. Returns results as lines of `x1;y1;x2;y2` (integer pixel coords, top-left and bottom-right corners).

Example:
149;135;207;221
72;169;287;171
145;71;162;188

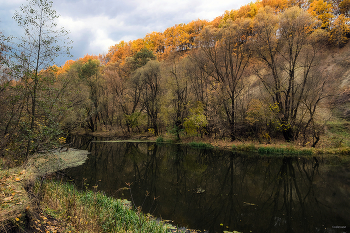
0;149;171;232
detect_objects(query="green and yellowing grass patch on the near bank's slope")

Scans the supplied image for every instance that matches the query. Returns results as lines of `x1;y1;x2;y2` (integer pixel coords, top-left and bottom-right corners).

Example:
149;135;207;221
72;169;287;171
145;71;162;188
33;180;170;232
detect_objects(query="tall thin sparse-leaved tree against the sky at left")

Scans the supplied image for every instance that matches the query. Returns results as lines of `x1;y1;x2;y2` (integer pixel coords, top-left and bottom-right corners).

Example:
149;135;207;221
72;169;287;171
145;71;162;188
13;0;70;156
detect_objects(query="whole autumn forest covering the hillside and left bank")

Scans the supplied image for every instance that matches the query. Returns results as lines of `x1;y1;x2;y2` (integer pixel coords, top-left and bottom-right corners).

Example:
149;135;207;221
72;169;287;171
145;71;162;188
0;0;350;161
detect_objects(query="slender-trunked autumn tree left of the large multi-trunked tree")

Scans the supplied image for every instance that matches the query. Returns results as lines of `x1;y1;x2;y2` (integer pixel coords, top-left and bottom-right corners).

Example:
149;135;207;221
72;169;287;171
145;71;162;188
195;19;251;140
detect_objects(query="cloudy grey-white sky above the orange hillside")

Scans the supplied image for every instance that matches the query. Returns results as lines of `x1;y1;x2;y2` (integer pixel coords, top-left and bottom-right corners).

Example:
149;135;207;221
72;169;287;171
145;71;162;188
0;0;251;65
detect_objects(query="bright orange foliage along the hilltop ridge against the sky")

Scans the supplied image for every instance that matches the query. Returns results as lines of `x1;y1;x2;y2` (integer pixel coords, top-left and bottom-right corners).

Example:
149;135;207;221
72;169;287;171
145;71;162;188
67;0;350;67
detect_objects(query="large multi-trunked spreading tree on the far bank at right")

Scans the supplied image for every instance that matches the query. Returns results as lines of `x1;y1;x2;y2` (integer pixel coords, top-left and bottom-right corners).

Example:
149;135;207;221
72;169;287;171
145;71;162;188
254;7;325;141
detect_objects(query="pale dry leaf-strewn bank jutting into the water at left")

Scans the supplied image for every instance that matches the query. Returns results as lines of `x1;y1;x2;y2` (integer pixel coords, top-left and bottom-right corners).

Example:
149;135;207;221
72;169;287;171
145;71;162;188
0;147;88;227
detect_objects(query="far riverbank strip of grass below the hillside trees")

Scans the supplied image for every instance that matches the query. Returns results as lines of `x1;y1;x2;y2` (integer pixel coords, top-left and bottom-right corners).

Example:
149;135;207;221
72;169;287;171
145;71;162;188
84;131;350;156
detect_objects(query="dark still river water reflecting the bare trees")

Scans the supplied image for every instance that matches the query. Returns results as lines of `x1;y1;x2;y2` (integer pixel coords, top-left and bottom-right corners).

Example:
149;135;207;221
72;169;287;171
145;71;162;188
65;139;350;232
